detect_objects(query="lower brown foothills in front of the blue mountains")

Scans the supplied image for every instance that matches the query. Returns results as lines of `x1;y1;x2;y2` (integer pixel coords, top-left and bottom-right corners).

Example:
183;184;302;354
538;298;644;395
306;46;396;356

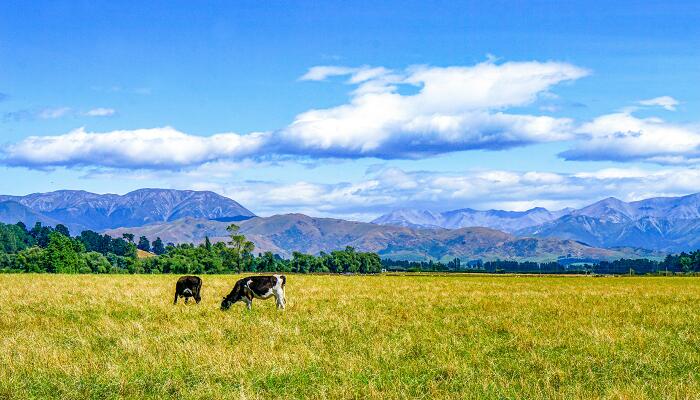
102;214;648;260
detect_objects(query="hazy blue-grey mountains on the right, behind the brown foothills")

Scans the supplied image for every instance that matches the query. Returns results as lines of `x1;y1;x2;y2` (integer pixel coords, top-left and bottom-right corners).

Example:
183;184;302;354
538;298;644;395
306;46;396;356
372;193;700;252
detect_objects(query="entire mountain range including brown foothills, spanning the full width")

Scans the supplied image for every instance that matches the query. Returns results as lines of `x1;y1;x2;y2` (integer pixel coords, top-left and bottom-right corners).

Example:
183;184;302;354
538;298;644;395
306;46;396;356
0;189;700;260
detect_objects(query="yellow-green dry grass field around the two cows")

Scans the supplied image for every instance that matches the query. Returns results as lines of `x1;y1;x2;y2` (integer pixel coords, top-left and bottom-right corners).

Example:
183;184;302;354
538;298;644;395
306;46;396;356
0;275;700;399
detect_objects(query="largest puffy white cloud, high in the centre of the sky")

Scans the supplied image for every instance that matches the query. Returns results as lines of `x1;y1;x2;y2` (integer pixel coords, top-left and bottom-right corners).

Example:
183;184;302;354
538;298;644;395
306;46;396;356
279;61;588;159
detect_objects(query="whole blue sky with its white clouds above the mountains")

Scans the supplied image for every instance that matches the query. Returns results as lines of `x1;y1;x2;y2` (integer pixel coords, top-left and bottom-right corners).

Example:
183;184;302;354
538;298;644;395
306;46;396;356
0;1;700;220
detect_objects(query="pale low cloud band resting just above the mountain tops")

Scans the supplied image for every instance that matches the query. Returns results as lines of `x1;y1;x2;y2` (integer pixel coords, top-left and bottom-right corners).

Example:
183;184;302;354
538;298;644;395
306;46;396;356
181;167;700;221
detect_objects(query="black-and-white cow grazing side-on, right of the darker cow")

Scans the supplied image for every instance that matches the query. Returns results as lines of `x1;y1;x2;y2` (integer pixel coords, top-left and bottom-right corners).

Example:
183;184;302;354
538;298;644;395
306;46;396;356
221;275;287;310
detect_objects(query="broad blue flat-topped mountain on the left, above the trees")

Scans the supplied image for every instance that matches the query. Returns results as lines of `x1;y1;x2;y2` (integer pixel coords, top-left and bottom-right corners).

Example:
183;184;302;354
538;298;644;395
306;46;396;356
0;189;255;231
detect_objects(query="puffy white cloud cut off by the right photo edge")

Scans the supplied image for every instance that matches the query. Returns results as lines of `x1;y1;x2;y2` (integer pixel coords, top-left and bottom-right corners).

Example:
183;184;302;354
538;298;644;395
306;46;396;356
560;111;700;164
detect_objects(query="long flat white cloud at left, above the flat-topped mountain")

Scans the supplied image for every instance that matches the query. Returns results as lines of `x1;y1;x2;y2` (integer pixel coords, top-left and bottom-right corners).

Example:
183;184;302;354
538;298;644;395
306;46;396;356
3;127;266;169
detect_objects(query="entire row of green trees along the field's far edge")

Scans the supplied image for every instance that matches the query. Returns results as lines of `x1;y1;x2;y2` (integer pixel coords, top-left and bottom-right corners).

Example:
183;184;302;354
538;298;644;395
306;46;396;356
0;222;700;274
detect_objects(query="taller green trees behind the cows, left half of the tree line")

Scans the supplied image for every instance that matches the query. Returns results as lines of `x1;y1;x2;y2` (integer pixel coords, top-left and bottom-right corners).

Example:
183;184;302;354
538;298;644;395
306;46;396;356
0;222;382;274
